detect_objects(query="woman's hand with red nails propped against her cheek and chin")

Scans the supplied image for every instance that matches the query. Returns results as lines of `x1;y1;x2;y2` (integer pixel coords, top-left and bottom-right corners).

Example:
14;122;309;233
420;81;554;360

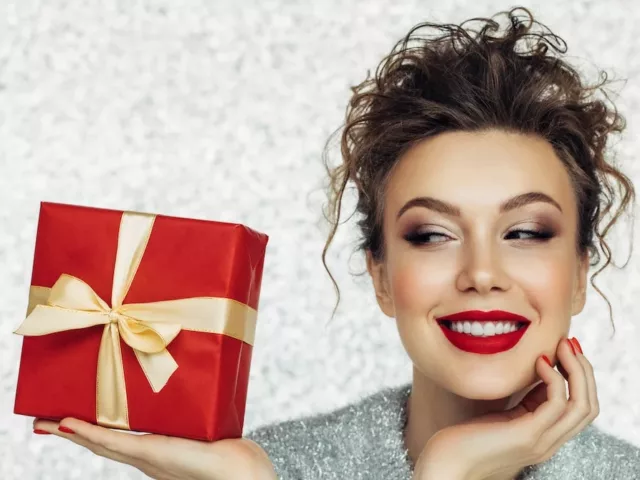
414;339;599;480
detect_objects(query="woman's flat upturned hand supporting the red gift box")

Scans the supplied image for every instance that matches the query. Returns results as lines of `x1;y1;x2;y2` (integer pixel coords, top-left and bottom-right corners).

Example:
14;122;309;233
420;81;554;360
33;418;277;480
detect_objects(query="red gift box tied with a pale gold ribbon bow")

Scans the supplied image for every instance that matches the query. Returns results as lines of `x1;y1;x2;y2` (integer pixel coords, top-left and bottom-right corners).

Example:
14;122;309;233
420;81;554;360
14;202;269;441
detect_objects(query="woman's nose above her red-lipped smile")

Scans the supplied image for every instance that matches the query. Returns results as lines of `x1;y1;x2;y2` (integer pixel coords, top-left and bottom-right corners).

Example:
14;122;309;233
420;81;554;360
456;242;510;295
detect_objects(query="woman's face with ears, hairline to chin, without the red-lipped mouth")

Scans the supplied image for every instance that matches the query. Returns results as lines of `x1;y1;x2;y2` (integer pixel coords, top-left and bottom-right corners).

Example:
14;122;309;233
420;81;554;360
367;130;588;400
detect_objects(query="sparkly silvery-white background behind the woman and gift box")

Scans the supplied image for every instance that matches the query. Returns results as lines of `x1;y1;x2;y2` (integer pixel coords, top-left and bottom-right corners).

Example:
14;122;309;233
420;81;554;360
0;0;640;480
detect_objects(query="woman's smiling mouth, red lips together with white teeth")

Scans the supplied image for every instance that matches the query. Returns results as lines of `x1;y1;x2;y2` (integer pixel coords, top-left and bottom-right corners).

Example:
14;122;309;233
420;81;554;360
436;310;531;354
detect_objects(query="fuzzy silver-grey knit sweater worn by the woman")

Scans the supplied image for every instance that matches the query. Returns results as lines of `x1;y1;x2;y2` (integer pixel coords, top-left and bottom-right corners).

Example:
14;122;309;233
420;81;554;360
245;385;640;480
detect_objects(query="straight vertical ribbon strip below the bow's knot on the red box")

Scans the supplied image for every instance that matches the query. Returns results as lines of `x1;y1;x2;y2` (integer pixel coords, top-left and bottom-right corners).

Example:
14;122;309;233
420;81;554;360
96;323;130;430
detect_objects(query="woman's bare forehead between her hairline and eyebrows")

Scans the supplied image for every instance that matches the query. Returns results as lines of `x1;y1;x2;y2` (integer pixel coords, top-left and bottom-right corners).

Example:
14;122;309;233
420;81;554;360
386;130;575;213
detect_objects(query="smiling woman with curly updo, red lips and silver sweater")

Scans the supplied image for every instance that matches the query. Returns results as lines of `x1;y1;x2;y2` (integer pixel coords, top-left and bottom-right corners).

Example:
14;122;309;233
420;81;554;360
34;9;640;480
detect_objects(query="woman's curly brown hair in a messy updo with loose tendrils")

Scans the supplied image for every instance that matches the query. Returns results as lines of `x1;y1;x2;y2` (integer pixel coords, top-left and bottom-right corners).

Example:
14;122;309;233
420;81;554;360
322;7;635;331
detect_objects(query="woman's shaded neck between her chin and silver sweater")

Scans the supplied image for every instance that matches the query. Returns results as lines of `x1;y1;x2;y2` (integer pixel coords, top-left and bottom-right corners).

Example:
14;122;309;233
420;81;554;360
405;368;519;480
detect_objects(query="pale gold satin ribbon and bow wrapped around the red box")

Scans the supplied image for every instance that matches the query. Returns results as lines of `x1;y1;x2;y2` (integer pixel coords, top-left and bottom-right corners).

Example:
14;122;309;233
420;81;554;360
14;212;257;430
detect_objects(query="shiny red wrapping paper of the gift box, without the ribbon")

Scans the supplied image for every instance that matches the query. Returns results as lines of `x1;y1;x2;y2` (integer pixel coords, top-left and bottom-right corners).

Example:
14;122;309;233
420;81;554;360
14;202;269;441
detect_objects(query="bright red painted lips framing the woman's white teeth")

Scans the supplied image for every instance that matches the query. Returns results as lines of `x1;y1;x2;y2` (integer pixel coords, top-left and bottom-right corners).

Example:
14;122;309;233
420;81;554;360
436;310;531;355
